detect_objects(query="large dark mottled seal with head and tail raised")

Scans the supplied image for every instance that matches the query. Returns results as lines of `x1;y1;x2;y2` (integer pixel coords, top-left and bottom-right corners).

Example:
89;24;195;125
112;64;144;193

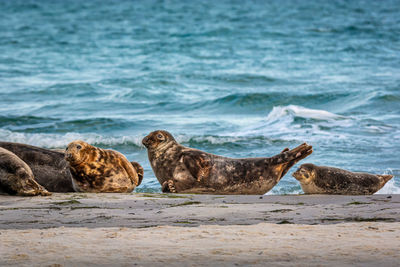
142;130;312;194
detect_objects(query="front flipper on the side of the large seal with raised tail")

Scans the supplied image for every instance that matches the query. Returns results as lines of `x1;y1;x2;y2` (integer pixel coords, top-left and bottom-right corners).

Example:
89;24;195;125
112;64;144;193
182;151;212;182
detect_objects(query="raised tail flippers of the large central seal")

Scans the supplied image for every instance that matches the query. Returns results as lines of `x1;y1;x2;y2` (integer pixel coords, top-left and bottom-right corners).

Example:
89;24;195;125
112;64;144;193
271;143;313;177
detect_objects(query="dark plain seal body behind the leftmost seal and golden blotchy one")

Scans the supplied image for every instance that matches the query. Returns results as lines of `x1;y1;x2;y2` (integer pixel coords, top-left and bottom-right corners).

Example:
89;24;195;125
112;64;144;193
0;142;74;192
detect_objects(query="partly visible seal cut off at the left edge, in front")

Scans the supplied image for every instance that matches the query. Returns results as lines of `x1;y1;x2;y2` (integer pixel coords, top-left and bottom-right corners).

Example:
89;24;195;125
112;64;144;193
0;147;51;196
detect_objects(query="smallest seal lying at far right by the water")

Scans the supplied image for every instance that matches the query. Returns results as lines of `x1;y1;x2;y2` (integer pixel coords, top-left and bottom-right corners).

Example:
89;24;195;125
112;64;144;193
292;163;393;195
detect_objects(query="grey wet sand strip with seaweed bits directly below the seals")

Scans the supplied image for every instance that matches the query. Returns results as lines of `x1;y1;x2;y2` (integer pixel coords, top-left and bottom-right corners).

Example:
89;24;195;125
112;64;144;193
0;193;400;229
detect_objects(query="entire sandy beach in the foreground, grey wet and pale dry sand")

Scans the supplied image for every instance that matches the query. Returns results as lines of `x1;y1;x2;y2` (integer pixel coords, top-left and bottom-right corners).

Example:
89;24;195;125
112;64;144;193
0;193;400;266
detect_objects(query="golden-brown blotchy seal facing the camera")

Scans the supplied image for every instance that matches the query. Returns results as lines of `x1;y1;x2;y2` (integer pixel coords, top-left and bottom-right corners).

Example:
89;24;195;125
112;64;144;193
65;140;143;193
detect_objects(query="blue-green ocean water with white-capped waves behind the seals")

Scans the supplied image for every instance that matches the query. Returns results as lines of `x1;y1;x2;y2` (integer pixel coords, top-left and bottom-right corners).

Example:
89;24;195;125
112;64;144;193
0;0;400;194
